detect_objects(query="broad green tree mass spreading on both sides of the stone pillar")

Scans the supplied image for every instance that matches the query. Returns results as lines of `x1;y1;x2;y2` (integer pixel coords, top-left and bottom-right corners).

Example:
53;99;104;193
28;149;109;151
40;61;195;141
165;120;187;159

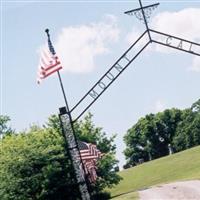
0;114;120;200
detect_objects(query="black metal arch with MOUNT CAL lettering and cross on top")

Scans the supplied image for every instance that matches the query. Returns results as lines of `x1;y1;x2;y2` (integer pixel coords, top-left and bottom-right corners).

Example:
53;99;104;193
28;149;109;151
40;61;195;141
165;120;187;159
70;0;200;122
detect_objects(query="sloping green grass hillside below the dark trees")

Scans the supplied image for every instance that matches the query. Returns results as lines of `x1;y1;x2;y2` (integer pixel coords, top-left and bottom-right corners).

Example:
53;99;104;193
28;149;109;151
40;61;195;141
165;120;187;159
109;146;200;199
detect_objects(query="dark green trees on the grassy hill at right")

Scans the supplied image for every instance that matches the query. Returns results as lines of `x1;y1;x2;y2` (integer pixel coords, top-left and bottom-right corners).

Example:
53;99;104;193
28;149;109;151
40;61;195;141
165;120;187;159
124;99;200;168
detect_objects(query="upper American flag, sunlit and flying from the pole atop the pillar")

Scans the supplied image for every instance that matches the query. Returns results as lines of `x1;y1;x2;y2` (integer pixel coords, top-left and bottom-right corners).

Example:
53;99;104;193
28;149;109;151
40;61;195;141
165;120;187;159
37;49;62;84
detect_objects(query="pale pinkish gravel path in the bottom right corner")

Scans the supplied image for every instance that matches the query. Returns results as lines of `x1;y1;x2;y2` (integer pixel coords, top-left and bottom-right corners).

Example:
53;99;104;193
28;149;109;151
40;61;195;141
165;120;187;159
139;180;200;200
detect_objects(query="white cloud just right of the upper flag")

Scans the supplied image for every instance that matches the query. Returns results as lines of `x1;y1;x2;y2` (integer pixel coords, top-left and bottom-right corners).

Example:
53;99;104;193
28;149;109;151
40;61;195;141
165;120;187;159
55;15;119;73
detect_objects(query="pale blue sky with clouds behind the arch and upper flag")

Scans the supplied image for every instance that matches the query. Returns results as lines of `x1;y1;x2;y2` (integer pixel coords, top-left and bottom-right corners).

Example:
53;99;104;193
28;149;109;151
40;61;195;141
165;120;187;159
1;0;200;169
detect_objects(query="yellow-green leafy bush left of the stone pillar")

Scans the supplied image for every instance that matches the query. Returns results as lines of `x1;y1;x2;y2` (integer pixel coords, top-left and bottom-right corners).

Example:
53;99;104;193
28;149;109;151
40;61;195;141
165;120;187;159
0;130;78;200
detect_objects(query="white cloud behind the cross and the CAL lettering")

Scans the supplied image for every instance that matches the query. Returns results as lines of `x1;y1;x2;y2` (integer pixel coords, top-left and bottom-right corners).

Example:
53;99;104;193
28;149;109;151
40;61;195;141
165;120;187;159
127;8;200;72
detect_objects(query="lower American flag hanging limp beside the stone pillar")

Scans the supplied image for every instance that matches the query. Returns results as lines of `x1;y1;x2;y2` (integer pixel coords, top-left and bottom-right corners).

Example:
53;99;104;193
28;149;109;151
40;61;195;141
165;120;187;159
78;141;102;182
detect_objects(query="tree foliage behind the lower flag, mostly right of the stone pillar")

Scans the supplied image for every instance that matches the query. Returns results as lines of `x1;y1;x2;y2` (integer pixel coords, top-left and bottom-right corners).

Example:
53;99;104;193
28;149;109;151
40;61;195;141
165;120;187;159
47;113;121;198
